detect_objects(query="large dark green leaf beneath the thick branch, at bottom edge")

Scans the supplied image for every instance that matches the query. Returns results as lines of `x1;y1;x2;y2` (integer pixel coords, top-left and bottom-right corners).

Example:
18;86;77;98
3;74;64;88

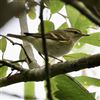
52;75;95;100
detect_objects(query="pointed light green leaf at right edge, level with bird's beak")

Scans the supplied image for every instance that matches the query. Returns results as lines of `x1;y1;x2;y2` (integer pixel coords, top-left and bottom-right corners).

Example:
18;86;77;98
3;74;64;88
80;32;100;46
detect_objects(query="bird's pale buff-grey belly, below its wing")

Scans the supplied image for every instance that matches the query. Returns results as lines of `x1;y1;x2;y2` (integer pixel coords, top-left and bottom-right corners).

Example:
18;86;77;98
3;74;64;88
34;40;73;57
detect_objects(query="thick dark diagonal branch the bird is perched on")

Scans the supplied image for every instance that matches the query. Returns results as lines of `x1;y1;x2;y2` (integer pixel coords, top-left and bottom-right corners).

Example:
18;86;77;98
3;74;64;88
0;54;100;87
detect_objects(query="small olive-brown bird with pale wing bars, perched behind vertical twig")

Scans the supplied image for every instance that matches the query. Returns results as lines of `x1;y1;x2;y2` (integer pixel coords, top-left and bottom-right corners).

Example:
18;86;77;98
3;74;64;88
7;28;89;57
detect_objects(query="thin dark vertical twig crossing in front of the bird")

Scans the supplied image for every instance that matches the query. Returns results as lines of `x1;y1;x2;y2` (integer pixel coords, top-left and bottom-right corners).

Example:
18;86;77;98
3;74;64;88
40;0;53;100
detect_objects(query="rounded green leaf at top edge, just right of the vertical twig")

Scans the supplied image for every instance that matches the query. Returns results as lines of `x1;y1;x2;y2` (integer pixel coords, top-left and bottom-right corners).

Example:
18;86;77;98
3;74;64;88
49;0;64;13
